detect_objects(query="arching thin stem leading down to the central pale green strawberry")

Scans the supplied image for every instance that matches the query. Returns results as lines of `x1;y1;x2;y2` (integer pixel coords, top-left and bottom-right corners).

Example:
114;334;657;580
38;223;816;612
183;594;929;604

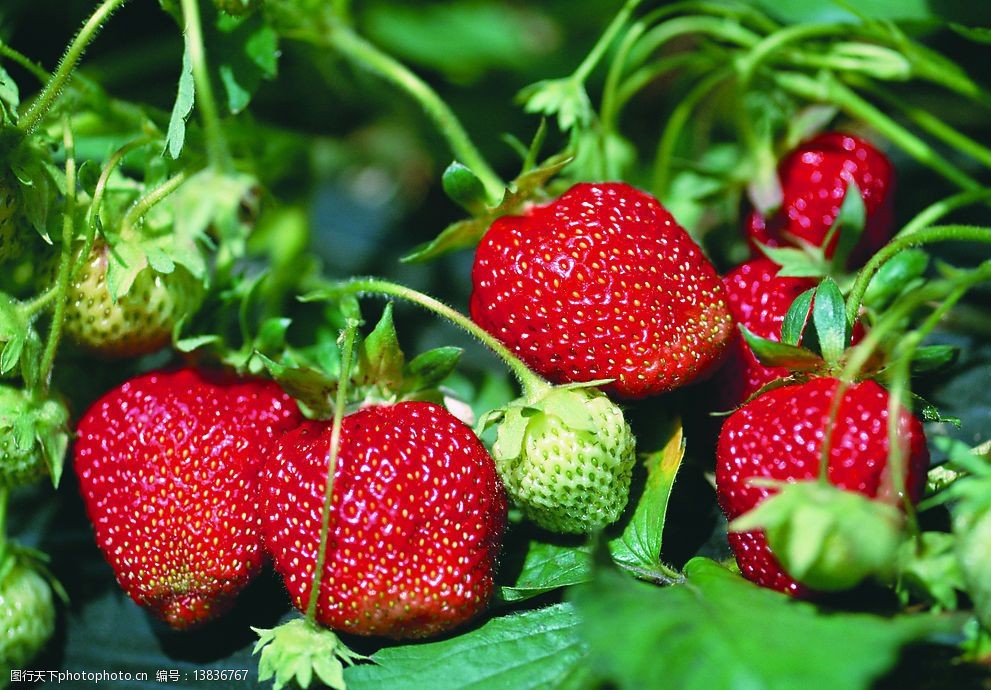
321;278;550;399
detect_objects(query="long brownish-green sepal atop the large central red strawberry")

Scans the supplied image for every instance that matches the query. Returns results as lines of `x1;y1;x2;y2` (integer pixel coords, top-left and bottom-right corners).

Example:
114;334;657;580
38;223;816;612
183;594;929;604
402;154;571;263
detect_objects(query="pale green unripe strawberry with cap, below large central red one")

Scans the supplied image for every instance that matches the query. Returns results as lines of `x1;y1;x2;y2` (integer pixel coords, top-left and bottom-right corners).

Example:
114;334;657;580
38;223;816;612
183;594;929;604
492;387;636;533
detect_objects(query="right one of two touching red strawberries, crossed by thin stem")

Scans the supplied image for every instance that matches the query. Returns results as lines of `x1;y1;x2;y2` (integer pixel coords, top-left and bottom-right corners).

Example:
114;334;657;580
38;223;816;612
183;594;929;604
259;402;506;638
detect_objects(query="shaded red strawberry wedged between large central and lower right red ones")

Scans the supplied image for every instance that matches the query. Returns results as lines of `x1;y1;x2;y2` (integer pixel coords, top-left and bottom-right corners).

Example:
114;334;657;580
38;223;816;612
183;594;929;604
717;258;816;407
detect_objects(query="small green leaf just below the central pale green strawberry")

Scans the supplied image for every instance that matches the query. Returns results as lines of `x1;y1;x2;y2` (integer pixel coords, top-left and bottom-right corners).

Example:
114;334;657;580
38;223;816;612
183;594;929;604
501;541;593;601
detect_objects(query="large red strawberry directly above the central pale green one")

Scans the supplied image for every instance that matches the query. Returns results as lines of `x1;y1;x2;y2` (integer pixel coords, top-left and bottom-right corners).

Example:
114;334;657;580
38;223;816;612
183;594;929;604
470;183;733;398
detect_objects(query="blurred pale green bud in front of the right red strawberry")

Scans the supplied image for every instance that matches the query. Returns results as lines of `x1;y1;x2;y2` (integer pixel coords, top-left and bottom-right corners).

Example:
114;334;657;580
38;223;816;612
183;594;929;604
729;480;905;591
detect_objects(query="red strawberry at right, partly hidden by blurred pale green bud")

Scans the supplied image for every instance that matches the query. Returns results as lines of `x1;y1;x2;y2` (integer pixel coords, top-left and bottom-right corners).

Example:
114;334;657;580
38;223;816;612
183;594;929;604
716;378;929;594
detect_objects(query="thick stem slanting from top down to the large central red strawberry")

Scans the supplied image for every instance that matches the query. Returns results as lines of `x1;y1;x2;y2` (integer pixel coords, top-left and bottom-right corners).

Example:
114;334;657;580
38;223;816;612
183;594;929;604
330;24;506;203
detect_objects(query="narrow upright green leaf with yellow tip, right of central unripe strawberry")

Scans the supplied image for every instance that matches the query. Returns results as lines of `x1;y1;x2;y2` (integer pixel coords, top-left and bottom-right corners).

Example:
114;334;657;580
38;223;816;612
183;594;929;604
609;420;685;573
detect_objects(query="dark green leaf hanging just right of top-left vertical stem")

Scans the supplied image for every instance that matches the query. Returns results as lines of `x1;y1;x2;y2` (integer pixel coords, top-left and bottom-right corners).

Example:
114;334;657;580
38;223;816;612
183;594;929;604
213;12;279;115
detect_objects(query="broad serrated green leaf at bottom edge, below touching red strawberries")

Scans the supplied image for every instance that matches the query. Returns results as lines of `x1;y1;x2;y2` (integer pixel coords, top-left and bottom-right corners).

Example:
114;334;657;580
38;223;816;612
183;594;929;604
344;604;586;690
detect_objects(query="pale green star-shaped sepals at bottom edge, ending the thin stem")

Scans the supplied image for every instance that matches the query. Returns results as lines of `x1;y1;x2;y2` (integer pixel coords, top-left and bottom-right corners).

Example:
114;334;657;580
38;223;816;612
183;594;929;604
251;618;368;690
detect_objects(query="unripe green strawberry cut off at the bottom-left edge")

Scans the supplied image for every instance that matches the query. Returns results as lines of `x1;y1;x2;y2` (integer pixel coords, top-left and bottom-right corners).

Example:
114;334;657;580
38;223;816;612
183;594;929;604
0;556;55;685
